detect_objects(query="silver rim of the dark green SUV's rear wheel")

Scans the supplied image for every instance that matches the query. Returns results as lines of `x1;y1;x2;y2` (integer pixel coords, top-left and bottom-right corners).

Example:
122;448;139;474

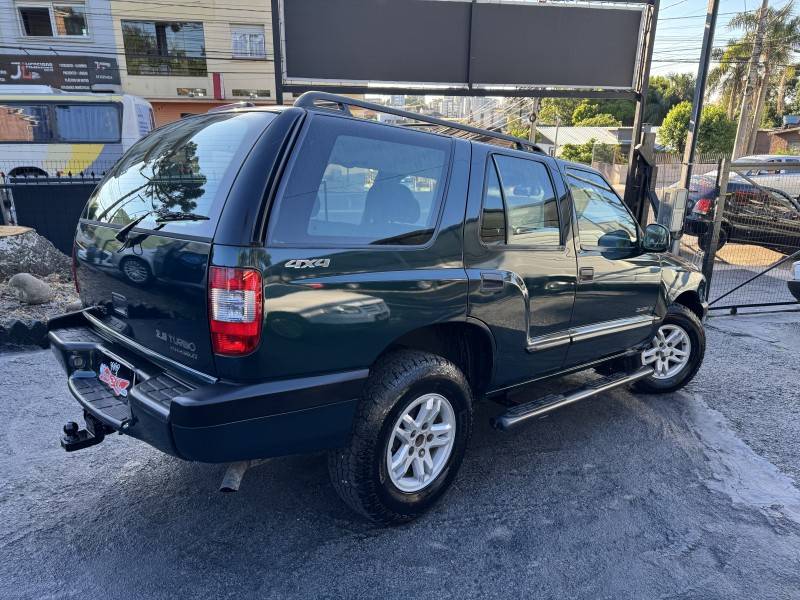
386;394;456;493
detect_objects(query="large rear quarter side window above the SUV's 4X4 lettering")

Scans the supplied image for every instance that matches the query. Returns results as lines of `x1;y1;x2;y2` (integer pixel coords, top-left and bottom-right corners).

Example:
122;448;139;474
269;116;451;247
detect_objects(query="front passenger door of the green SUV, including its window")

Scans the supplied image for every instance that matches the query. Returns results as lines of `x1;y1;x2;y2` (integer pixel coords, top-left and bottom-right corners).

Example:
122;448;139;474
566;167;661;366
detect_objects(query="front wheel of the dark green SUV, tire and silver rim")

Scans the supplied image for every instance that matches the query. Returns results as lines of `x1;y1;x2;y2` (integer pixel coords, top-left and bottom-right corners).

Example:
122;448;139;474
634;304;706;394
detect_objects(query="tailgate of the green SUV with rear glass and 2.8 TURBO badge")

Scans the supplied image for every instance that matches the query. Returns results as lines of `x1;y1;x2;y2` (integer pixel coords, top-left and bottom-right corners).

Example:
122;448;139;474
75;112;274;374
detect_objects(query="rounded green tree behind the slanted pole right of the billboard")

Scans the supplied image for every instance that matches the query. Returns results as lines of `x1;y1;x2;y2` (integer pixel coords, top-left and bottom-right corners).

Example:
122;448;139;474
658;102;736;153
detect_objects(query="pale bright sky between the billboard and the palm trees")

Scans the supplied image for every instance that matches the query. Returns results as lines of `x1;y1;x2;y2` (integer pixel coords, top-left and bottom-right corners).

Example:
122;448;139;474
650;0;788;75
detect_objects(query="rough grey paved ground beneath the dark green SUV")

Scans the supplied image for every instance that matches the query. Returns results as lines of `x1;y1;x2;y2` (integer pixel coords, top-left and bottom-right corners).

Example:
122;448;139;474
0;314;800;600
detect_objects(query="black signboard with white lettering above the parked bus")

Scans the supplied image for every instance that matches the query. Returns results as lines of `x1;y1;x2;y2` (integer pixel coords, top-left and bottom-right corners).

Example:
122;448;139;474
0;54;120;92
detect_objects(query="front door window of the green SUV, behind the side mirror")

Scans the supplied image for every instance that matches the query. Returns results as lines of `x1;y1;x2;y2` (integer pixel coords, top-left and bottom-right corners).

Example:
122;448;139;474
567;169;638;248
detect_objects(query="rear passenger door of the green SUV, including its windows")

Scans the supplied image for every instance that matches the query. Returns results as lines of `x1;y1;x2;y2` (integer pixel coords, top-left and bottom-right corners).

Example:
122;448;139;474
464;145;577;387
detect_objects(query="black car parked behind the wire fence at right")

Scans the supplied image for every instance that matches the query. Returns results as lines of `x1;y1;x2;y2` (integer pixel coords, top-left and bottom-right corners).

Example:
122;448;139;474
684;178;800;254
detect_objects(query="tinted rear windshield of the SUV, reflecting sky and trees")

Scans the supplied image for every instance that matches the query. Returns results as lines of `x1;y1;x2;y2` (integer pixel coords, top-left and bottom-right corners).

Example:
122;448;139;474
83;112;275;238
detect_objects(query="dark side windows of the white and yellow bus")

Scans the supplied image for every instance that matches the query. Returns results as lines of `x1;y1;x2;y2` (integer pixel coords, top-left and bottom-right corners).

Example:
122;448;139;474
0;103;121;144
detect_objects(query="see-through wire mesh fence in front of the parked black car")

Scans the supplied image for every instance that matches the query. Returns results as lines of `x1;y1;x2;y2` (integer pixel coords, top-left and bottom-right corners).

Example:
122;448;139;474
592;151;800;313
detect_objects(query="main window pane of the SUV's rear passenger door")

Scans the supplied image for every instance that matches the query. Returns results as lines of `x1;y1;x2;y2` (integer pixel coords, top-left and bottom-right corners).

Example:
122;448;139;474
494;155;561;246
